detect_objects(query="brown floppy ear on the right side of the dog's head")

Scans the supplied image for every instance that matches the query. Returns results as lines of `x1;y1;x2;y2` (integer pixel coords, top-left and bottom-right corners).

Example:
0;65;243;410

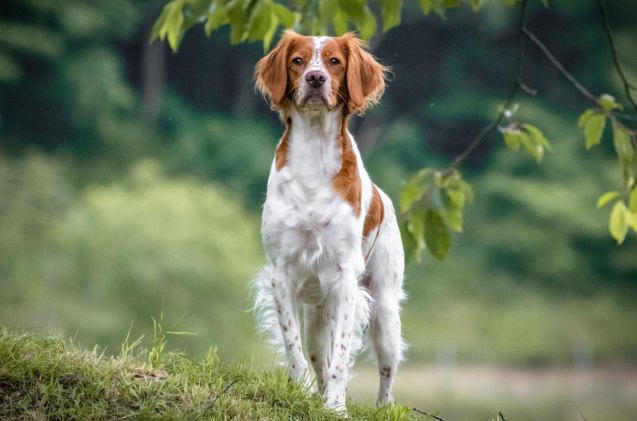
343;33;389;114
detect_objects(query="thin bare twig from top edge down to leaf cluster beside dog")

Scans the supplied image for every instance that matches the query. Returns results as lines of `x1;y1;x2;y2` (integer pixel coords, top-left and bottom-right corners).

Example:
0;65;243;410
442;0;527;174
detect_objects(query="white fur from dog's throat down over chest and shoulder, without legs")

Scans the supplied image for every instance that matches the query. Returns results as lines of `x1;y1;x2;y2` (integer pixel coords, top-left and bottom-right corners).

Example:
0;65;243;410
262;106;371;288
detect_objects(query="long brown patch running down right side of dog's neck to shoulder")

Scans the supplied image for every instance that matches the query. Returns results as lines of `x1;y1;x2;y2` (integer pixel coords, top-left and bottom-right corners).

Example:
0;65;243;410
332;124;363;216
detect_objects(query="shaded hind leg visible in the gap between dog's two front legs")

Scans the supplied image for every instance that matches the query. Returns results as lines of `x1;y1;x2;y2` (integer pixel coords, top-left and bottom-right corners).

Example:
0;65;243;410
303;304;329;393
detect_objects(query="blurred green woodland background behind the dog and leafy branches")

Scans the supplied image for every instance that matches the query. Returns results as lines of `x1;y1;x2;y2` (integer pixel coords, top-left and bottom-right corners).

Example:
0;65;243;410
0;0;637;420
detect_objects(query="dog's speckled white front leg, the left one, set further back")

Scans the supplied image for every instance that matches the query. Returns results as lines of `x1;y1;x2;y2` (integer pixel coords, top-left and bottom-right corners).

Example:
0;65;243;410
272;264;311;388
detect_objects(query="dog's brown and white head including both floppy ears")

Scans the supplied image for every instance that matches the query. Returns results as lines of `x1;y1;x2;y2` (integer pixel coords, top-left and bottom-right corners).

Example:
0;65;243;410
255;31;387;114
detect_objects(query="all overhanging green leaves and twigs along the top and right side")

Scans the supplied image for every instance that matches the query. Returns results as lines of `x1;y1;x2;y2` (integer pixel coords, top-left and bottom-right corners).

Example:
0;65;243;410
151;0;637;259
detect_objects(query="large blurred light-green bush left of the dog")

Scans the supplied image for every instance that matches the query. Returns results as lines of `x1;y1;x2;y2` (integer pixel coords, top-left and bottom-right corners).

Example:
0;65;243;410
0;156;262;357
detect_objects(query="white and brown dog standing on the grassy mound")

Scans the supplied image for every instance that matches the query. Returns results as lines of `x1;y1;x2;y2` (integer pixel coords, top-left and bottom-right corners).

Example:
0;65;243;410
255;32;404;412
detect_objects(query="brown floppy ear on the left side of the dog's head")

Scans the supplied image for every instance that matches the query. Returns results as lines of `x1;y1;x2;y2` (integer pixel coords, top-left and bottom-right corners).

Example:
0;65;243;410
254;31;295;108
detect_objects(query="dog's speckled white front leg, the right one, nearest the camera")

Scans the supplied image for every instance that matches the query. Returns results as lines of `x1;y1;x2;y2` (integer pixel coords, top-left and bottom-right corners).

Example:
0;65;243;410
324;267;357;412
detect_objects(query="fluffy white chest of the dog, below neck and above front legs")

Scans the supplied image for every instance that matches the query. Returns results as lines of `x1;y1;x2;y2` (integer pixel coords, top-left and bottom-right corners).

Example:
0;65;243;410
262;131;360;266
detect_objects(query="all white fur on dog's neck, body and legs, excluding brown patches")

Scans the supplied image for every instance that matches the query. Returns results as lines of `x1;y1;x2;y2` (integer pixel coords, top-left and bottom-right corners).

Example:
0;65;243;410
254;38;404;412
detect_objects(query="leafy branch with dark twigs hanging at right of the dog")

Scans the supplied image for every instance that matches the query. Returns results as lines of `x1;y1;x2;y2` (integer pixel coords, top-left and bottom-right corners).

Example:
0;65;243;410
401;0;637;259
